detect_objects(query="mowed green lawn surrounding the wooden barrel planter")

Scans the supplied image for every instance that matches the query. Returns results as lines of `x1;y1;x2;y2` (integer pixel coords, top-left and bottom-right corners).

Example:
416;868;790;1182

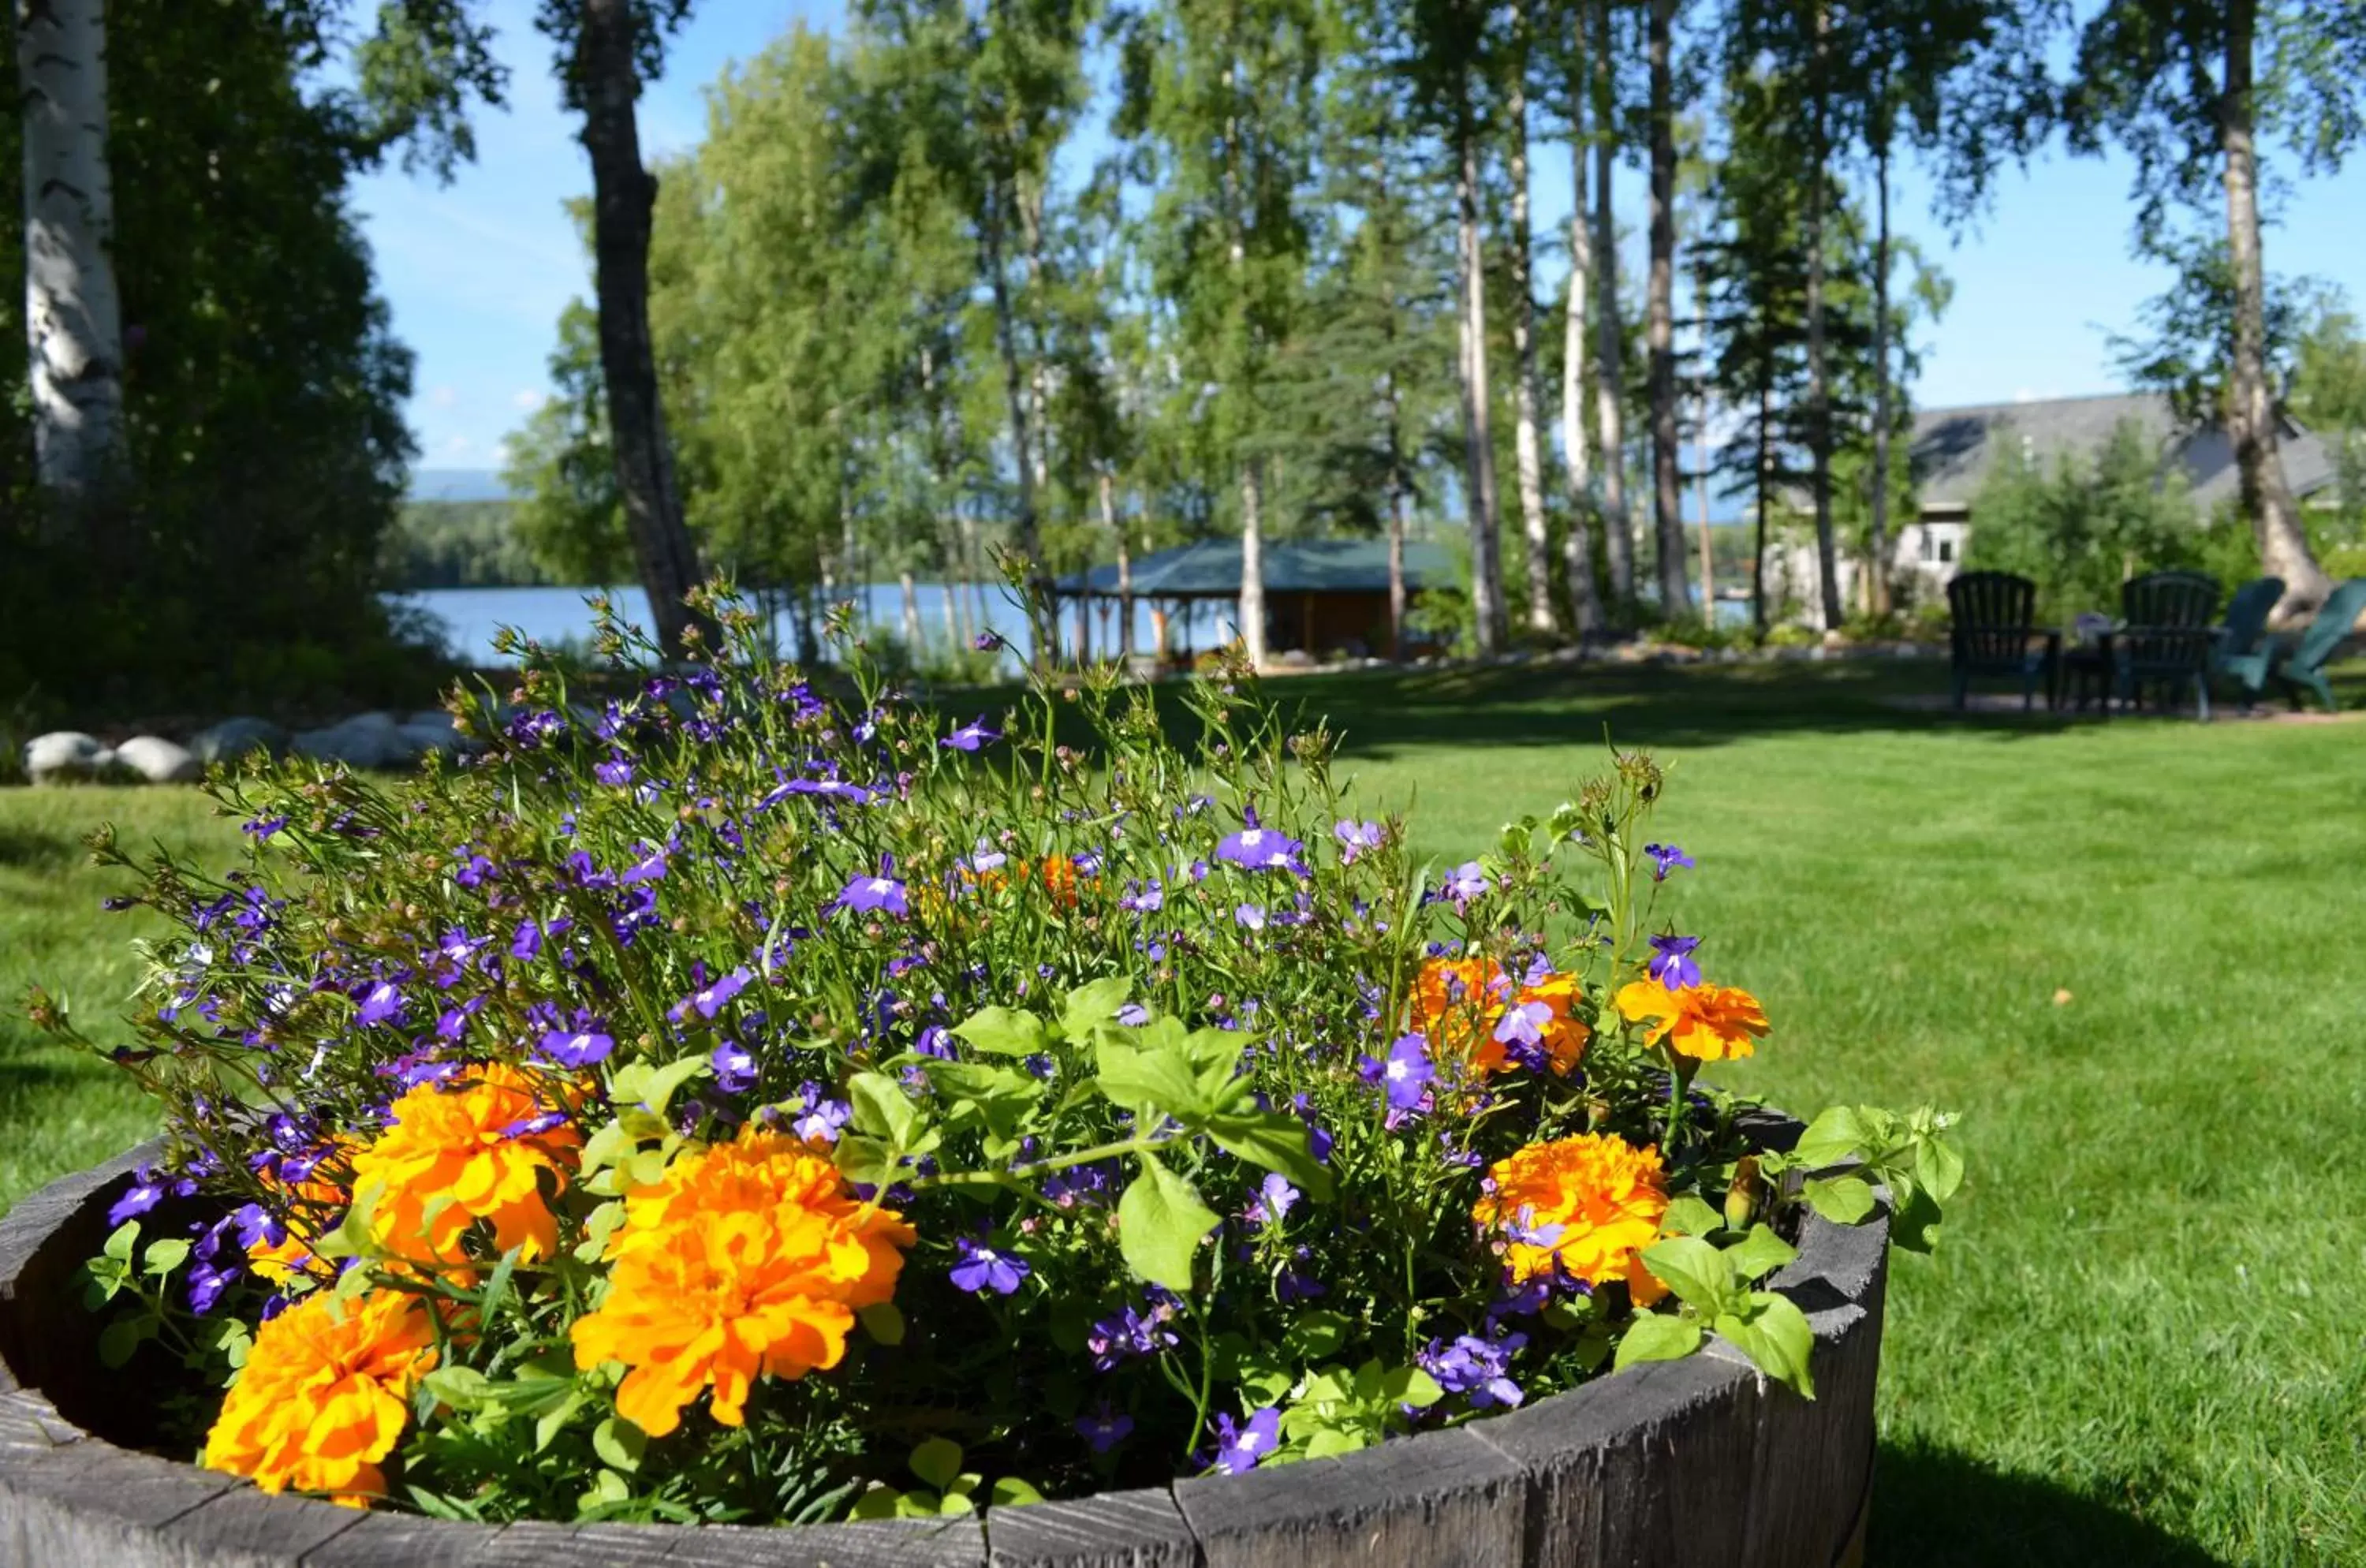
0;665;2366;1568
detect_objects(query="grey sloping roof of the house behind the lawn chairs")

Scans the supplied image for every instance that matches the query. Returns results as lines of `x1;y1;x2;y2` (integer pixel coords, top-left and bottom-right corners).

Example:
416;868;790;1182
1912;393;2335;511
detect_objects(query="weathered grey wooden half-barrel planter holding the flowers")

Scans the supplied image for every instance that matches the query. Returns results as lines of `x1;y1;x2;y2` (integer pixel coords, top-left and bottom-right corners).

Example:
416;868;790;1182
0;1123;1888;1568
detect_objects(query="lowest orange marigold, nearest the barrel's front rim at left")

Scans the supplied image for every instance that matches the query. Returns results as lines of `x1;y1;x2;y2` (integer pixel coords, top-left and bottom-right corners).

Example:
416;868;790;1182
206;1291;435;1509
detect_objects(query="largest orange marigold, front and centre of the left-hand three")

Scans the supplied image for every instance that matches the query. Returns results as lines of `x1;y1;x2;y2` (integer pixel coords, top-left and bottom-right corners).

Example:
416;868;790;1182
573;1126;913;1438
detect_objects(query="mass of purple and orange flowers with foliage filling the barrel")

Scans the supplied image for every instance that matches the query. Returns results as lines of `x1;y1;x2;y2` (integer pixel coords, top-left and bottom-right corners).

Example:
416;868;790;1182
35;586;1959;1521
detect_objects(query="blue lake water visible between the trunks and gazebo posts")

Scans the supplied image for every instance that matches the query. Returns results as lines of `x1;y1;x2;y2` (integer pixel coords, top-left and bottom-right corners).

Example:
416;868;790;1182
388;582;1202;670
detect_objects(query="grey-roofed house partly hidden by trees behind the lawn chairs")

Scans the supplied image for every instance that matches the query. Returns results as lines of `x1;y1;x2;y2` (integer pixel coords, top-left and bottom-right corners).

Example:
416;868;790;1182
1767;393;2338;603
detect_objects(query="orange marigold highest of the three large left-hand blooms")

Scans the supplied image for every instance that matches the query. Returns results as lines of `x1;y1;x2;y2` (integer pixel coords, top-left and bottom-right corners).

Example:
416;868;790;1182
353;1062;582;1263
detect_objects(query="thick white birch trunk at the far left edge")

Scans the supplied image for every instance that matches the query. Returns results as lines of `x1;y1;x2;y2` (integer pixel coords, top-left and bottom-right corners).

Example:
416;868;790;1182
17;0;123;537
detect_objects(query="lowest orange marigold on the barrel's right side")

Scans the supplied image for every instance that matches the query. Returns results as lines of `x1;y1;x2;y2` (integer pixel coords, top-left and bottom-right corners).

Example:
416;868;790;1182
1472;1133;1668;1305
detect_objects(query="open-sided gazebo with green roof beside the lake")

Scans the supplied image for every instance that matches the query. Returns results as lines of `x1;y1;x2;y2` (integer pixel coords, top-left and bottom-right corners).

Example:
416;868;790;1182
1053;539;1455;658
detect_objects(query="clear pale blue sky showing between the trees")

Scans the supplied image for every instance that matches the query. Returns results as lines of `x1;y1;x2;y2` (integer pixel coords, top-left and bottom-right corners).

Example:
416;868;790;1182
353;0;2366;469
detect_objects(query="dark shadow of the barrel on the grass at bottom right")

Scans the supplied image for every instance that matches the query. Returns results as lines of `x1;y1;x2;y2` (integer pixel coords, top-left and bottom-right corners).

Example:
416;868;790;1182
1864;1443;2234;1568
